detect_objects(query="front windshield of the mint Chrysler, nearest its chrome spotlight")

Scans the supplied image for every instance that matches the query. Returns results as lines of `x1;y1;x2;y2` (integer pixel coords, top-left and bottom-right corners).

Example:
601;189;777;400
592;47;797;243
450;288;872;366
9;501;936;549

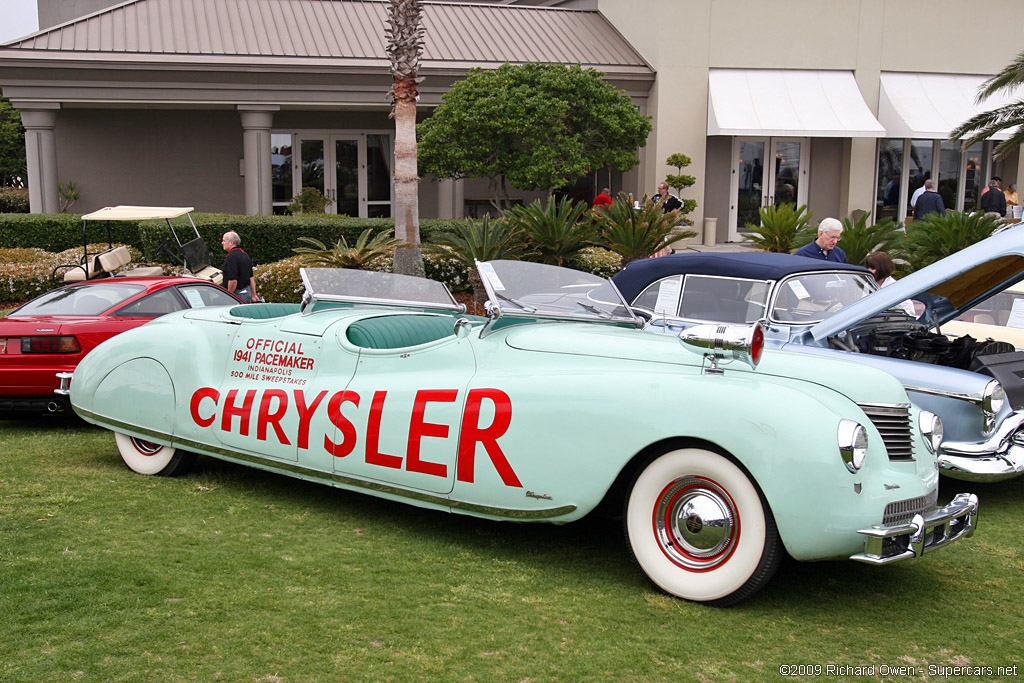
477;261;638;325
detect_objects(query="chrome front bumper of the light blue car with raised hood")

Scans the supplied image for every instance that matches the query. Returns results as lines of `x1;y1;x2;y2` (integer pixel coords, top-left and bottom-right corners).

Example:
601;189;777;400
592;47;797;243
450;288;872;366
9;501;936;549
938;412;1024;481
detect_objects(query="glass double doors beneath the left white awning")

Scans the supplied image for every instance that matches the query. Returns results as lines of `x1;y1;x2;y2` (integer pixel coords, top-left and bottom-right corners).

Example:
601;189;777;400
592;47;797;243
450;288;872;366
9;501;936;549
729;137;808;241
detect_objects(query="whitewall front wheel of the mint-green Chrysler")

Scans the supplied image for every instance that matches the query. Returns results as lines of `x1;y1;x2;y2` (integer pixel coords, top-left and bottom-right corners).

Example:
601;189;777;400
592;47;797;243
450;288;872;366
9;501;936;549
625;449;782;607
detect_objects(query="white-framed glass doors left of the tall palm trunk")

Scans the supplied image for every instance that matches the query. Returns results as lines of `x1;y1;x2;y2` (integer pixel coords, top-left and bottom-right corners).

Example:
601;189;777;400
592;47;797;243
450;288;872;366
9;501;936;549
292;133;393;218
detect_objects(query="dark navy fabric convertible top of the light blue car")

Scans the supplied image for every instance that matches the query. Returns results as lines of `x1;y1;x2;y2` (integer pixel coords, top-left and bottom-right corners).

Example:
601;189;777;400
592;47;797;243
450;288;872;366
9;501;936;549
611;252;869;301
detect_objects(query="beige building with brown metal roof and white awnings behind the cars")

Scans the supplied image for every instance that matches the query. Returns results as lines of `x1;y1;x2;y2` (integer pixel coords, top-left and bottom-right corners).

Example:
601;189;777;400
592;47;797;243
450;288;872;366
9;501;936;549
0;0;1024;241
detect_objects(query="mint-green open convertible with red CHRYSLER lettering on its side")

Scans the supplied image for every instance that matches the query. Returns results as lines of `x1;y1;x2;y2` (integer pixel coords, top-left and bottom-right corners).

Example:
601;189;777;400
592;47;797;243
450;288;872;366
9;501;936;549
67;261;978;605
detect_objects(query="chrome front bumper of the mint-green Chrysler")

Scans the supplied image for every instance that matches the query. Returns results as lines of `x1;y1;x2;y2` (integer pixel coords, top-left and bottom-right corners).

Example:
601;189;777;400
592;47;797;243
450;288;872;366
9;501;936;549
850;494;978;564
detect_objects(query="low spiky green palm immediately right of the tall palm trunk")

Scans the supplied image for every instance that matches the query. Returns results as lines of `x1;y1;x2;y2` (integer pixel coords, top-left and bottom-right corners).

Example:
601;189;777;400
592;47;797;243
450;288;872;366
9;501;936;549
424;214;523;306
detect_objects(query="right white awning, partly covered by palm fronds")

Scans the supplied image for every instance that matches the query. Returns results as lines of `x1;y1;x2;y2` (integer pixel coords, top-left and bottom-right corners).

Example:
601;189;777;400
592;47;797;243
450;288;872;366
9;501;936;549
879;72;1015;140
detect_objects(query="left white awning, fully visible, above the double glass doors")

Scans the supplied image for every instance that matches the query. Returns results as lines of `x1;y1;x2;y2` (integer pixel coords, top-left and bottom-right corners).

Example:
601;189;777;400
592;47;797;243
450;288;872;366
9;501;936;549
708;69;886;137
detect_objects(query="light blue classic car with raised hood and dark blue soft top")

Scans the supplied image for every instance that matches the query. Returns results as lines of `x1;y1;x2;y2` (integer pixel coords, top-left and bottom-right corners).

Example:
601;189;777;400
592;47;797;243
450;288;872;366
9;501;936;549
613;232;1024;481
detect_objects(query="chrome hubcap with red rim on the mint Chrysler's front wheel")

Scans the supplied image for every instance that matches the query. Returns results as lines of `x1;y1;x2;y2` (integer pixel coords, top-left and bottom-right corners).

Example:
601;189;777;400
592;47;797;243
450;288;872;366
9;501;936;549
654;476;739;569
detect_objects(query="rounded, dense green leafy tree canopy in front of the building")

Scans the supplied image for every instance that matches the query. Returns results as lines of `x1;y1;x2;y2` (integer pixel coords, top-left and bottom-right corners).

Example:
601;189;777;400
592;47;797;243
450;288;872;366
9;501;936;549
419;63;651;196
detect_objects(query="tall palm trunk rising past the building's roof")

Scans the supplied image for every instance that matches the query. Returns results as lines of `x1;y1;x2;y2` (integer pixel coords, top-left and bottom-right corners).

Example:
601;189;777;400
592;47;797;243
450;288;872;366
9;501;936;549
384;0;425;276
